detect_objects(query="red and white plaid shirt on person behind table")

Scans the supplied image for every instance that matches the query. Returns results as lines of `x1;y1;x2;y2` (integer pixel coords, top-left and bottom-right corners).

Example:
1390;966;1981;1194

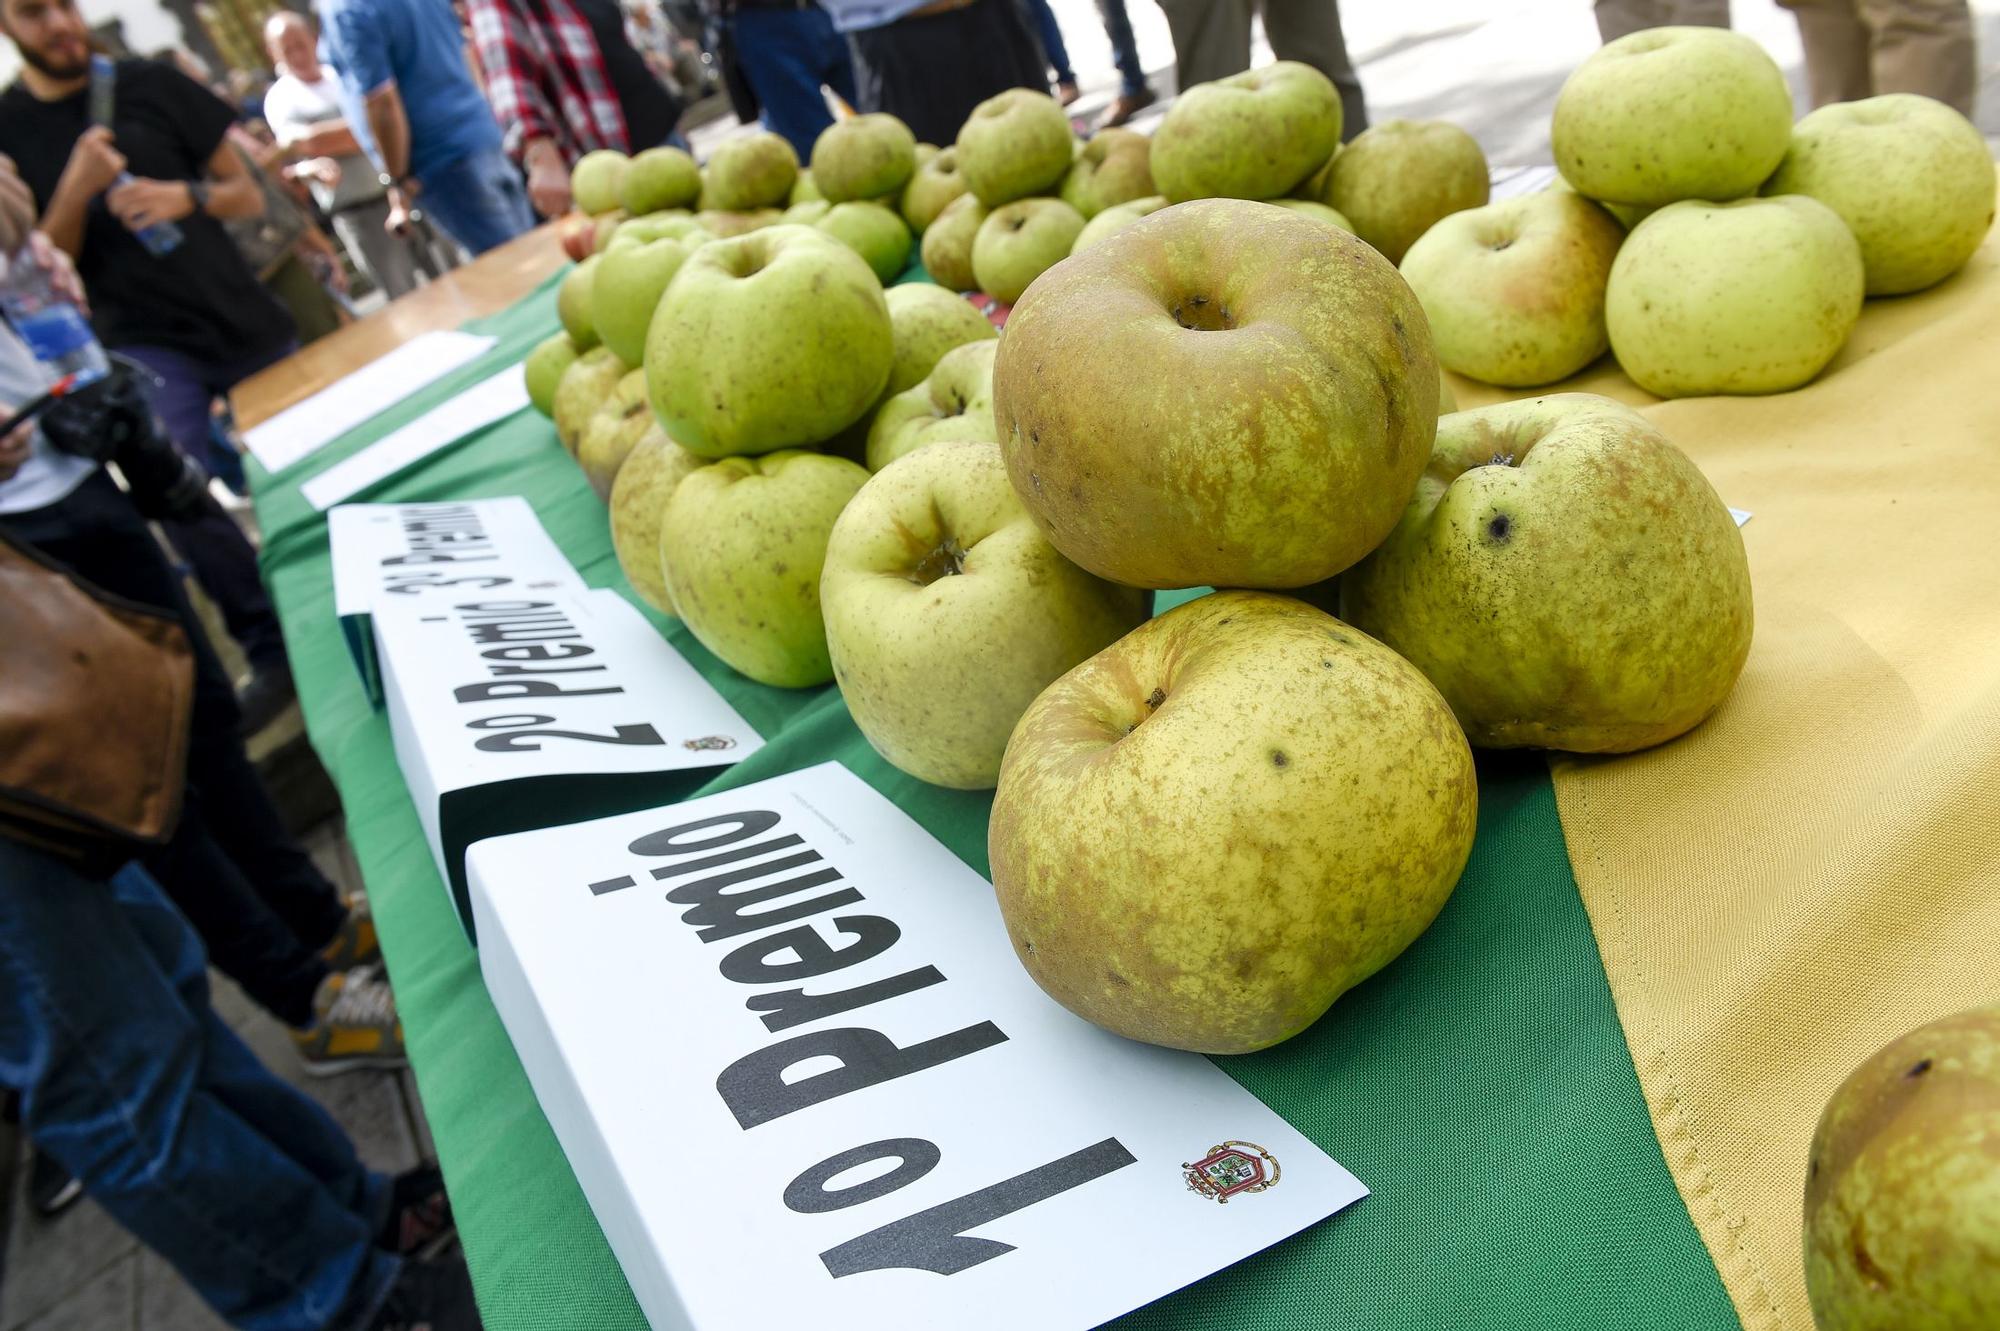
466;0;630;166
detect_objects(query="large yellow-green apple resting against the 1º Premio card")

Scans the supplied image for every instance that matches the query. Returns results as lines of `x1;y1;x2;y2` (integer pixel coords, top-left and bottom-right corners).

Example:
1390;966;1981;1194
992;587;1478;1053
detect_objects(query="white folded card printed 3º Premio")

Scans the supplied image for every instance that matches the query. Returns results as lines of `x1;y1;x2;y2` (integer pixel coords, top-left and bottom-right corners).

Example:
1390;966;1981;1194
326;496;588;703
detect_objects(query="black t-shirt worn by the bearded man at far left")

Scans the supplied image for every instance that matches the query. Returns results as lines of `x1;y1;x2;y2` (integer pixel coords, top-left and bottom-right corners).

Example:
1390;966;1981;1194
0;60;296;362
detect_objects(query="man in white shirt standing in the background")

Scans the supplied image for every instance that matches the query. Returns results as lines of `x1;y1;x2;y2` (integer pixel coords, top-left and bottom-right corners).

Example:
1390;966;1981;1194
264;10;416;300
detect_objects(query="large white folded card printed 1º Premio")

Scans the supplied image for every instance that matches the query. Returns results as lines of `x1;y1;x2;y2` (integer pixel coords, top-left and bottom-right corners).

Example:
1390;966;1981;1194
468;763;1366;1331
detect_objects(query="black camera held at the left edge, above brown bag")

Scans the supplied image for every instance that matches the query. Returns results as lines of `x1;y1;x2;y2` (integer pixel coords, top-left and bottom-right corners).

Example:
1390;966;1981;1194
42;354;212;518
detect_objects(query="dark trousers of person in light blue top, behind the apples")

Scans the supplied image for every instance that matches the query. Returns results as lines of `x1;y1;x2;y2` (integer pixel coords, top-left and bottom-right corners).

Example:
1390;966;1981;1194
848;0;1048;144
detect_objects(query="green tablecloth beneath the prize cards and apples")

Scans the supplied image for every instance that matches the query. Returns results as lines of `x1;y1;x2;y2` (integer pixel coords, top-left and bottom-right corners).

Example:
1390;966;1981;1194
252;284;1738;1331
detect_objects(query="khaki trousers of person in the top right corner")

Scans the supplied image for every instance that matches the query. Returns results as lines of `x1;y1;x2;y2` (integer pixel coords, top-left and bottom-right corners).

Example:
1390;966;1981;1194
1778;0;1978;116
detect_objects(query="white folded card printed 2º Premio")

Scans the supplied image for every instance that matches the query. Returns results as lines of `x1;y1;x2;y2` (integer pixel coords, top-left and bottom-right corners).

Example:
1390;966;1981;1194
374;590;764;935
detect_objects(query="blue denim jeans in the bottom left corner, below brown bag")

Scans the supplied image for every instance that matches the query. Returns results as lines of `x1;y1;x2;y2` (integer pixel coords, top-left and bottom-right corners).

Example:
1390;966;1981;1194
0;837;400;1331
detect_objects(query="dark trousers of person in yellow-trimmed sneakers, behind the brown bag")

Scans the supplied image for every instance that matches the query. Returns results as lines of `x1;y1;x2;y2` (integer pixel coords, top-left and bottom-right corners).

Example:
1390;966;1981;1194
0;472;346;1025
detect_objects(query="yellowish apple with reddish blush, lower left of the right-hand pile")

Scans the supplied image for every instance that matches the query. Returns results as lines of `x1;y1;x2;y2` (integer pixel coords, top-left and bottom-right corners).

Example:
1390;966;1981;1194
1402;190;1624;388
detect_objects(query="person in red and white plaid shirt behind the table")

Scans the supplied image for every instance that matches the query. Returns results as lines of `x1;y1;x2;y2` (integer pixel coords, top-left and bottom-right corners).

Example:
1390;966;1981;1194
466;0;680;218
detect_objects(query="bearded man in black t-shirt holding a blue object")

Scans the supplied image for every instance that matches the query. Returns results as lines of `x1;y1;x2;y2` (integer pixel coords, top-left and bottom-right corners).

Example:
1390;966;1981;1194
0;0;294;721
